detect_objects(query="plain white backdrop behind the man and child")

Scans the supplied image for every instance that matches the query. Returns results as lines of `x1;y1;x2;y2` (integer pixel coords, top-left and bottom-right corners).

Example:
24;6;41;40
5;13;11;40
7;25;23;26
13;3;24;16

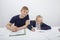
0;0;60;27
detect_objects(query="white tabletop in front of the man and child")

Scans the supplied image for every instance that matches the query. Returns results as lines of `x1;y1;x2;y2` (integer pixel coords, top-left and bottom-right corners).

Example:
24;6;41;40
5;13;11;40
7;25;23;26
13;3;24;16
0;27;60;40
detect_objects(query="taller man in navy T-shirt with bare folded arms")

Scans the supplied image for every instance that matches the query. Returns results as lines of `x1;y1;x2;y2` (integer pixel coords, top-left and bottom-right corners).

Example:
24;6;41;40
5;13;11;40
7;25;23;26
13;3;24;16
6;6;29;32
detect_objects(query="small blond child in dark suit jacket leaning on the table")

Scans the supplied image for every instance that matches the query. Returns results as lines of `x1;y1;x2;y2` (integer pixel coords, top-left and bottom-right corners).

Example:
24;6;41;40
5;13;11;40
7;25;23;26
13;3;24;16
28;15;51;31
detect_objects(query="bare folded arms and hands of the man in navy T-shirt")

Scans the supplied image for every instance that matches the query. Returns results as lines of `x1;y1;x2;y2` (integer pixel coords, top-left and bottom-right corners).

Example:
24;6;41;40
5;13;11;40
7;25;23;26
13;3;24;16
6;20;29;32
